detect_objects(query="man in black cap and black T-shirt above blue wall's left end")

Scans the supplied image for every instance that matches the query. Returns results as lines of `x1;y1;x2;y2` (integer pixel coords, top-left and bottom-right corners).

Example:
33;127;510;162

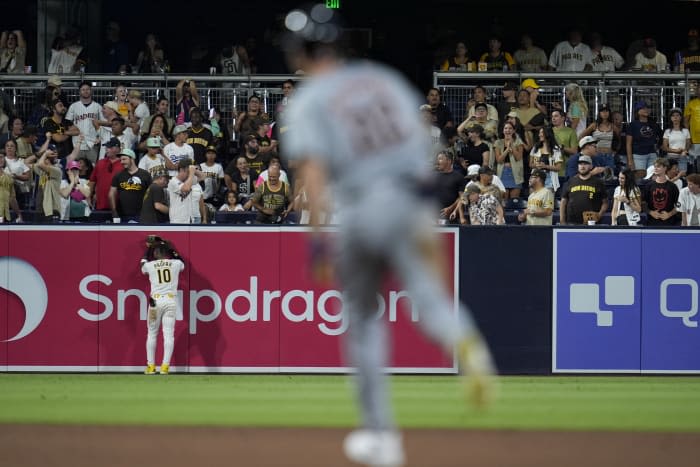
559;155;608;225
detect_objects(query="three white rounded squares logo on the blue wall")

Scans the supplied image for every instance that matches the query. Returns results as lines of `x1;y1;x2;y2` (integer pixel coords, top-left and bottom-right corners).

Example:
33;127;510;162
569;276;634;327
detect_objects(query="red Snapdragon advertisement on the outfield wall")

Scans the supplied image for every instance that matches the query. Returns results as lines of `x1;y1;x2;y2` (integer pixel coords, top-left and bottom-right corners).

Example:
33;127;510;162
0;225;458;373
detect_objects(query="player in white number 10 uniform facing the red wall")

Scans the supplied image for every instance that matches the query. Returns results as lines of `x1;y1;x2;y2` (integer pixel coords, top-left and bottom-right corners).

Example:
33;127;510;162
141;235;185;375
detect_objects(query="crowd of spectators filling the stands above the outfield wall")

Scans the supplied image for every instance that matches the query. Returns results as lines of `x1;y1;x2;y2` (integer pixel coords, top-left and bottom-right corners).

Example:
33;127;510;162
0;23;700;225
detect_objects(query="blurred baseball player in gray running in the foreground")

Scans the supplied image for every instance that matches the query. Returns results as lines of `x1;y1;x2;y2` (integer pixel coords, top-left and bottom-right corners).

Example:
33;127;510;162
280;4;494;467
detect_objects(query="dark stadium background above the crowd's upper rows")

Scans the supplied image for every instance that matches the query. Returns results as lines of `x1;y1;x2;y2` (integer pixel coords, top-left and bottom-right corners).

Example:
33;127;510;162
0;0;700;87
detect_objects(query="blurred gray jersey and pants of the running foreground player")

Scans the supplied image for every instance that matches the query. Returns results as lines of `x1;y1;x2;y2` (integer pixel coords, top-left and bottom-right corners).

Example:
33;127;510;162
281;62;482;429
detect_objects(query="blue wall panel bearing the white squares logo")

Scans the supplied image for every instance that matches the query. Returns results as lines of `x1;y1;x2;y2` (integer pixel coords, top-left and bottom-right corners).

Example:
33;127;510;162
552;229;642;373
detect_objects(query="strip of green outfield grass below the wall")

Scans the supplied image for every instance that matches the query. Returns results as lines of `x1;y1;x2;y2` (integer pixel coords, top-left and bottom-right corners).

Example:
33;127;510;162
0;374;700;432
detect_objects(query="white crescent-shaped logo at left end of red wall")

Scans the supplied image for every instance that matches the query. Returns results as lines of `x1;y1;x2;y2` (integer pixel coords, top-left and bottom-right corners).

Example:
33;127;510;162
0;256;49;342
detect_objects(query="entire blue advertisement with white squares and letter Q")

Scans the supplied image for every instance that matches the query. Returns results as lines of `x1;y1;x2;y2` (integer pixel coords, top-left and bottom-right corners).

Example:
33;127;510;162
552;229;700;373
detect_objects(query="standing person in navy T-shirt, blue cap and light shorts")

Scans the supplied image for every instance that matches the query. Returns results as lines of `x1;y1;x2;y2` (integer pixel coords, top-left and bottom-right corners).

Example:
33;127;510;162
626;101;663;180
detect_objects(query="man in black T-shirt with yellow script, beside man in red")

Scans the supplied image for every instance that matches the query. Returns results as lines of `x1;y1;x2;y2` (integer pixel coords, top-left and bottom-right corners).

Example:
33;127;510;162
109;148;152;223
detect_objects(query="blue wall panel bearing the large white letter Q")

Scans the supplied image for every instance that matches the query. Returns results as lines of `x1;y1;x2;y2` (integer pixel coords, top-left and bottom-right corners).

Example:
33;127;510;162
641;230;700;373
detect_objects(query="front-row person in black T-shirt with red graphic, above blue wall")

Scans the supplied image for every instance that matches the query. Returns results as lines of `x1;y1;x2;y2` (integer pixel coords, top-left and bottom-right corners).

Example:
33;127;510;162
644;157;680;226
